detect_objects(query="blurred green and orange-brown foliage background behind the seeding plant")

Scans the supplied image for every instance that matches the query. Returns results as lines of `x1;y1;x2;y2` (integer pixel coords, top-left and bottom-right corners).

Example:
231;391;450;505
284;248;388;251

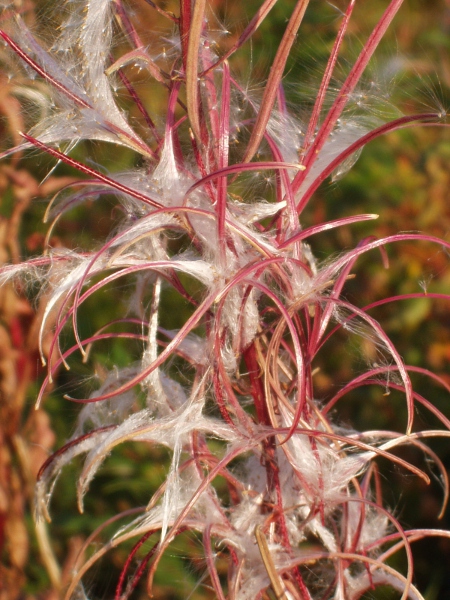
0;0;450;600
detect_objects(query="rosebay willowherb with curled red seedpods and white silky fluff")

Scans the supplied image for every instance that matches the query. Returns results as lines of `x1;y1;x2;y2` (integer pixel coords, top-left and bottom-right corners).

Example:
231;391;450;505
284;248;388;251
0;0;450;600
